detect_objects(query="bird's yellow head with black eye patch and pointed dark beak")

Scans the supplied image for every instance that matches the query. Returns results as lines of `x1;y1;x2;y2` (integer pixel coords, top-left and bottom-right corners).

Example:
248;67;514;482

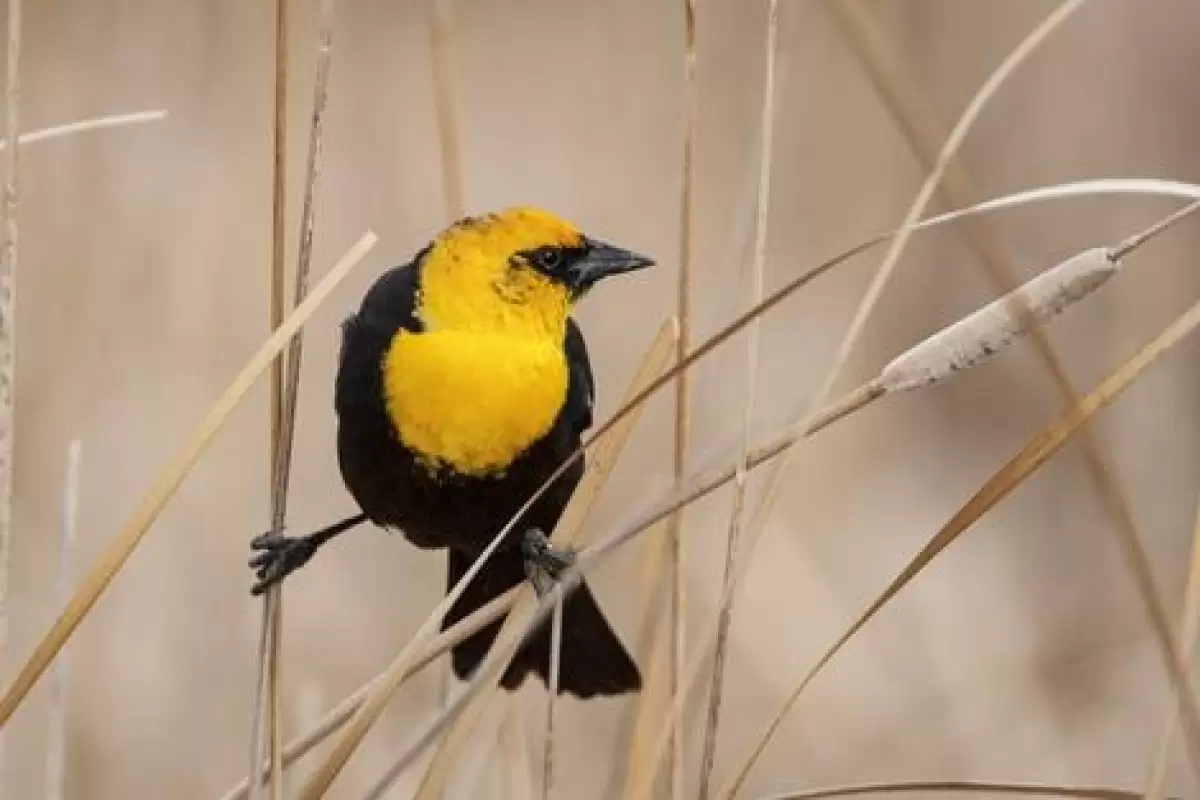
418;206;654;341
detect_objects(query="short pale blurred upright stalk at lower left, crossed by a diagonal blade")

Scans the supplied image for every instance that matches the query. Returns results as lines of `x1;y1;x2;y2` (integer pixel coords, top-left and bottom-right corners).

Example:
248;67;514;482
46;439;82;800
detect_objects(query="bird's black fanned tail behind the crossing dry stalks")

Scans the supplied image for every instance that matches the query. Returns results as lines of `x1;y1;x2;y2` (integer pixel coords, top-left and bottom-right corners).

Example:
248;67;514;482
442;549;642;698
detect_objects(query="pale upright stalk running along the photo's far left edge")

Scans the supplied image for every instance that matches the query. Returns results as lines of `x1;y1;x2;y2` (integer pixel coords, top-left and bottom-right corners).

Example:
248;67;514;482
0;0;22;794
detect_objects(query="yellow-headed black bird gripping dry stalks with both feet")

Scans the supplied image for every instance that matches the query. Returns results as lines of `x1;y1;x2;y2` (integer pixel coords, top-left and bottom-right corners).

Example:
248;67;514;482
250;205;654;699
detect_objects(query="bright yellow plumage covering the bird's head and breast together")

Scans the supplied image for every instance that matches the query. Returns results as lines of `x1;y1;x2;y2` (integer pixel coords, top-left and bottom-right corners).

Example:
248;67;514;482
384;207;582;476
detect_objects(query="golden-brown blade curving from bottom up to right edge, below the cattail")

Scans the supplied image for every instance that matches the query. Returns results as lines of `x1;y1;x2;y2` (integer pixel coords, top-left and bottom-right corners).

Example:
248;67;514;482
721;293;1200;800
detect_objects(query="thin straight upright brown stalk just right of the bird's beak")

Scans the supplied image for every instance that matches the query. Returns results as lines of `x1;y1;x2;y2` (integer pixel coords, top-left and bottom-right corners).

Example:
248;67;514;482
660;0;698;800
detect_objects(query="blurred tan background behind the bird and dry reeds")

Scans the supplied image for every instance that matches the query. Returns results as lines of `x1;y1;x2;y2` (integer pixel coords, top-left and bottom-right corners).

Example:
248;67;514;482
4;0;1200;800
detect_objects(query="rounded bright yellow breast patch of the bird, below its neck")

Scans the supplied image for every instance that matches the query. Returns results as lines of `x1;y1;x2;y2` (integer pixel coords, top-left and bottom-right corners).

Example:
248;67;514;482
383;330;569;475
